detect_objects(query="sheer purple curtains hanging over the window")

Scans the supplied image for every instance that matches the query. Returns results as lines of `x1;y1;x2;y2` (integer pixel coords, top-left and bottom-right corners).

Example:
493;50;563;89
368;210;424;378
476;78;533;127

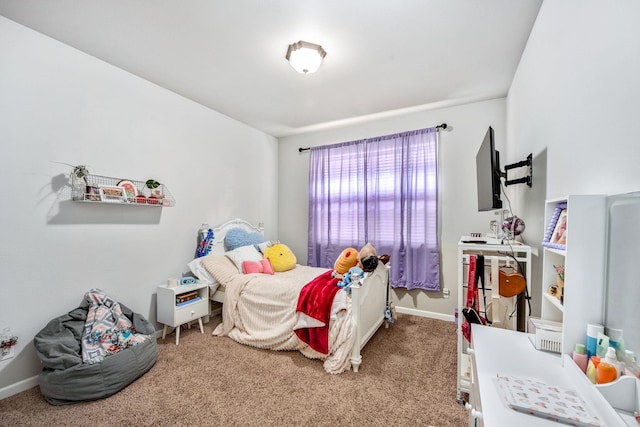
307;128;440;290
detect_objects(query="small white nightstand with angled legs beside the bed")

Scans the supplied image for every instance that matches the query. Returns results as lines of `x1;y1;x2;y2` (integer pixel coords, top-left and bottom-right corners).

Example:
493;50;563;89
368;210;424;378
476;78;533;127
157;283;209;345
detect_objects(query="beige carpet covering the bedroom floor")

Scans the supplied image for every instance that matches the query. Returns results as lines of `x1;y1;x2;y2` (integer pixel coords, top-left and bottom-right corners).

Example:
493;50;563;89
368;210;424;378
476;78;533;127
0;315;467;427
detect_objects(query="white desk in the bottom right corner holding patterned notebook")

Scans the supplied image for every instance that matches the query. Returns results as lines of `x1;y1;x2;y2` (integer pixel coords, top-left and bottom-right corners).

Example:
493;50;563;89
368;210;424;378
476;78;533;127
469;325;626;427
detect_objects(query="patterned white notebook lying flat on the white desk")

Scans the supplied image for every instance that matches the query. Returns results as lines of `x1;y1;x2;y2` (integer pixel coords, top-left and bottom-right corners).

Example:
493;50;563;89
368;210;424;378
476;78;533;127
496;374;603;427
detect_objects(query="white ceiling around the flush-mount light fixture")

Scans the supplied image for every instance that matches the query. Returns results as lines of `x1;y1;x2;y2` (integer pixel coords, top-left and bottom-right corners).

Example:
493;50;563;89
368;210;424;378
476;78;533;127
0;0;542;137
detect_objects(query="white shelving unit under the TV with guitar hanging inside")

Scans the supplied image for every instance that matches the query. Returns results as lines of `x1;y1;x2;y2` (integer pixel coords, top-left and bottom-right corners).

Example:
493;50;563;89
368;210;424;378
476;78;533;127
457;241;532;402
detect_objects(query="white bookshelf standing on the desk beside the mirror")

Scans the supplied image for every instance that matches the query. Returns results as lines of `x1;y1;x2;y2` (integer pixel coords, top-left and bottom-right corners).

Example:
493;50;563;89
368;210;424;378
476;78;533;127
541;195;606;360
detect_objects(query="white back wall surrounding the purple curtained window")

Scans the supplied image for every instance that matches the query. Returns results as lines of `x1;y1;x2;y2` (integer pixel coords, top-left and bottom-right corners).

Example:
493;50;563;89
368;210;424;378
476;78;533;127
278;98;505;318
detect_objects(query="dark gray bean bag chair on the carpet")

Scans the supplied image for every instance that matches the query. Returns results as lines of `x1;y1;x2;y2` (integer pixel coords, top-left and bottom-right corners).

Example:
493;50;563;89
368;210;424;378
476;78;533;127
33;298;158;405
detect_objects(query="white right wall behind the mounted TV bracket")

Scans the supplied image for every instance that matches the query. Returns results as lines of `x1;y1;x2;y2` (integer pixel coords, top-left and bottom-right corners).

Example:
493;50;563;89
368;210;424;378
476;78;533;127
507;0;640;313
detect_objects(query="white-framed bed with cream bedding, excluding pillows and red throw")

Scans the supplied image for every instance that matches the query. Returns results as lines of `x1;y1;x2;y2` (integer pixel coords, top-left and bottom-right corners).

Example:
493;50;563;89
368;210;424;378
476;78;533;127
189;219;389;374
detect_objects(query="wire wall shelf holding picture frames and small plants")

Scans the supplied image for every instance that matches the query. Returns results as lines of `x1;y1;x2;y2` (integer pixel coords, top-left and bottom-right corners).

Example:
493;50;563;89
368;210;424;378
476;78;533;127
71;173;176;208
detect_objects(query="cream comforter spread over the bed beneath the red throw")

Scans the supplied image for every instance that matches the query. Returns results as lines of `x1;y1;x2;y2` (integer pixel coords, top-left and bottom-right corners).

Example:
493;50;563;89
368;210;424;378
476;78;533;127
203;256;356;374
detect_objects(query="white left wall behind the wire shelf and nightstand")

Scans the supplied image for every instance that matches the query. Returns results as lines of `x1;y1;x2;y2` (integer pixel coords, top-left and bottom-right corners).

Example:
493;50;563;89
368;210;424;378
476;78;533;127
0;17;278;398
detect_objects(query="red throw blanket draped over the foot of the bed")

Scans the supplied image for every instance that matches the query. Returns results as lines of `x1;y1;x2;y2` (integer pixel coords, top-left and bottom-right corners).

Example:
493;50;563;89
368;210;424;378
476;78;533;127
294;270;340;354
